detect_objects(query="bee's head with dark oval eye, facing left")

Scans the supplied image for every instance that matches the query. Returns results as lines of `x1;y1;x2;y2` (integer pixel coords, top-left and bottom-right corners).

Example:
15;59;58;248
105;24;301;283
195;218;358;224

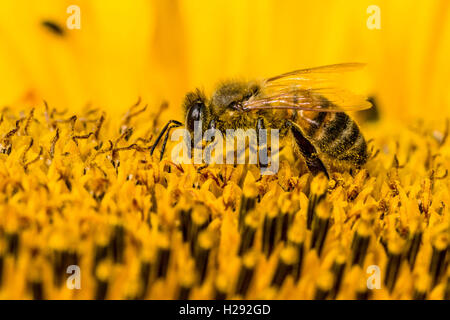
183;90;209;136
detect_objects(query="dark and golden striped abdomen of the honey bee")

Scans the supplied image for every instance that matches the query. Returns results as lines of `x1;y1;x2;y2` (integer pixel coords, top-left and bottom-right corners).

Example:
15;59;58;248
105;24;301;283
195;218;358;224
296;111;368;166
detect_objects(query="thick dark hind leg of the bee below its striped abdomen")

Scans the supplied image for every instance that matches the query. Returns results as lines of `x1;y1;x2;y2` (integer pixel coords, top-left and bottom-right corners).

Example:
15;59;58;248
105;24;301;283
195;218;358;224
287;121;329;178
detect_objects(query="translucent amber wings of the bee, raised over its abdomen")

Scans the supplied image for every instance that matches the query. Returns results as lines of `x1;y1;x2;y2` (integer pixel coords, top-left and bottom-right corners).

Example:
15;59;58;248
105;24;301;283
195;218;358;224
242;63;372;112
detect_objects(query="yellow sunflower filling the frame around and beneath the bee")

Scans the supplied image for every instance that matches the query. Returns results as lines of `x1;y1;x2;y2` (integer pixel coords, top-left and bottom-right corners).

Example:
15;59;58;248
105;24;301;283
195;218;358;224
0;0;450;299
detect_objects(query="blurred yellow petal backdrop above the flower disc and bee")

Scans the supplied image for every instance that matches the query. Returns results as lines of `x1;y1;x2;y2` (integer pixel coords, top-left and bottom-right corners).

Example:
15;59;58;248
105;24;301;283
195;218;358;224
0;0;450;121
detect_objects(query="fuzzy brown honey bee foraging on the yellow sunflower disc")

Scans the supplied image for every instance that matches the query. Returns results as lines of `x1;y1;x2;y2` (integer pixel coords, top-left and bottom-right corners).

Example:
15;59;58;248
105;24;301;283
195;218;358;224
151;63;371;176
